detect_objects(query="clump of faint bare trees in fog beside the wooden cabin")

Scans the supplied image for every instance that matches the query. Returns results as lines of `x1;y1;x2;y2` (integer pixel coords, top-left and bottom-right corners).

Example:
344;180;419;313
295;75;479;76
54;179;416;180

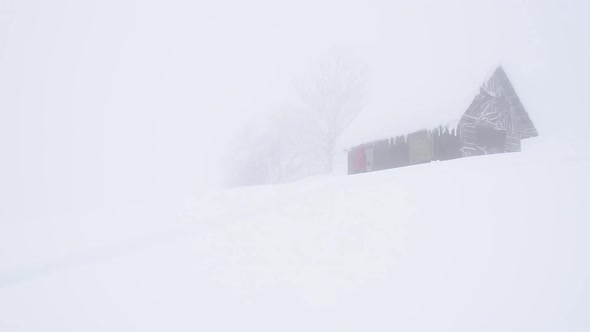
228;56;366;185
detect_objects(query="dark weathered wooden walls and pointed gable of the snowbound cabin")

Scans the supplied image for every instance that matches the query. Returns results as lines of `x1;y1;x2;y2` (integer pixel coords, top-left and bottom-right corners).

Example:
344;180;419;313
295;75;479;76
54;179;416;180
348;67;538;174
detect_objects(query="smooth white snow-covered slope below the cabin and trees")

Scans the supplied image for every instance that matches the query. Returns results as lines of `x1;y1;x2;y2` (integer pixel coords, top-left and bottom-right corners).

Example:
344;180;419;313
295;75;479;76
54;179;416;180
0;139;590;332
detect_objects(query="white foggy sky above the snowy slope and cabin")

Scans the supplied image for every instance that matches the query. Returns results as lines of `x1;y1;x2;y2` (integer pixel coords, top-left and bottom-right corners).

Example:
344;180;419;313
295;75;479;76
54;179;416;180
0;0;590;221
